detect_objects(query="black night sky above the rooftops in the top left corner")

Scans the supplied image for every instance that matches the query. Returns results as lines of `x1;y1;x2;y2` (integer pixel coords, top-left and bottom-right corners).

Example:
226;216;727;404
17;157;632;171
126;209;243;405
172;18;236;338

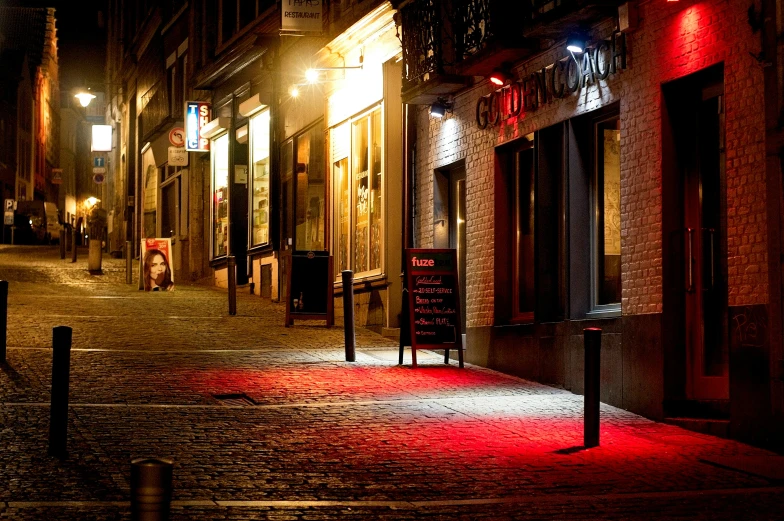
0;0;106;90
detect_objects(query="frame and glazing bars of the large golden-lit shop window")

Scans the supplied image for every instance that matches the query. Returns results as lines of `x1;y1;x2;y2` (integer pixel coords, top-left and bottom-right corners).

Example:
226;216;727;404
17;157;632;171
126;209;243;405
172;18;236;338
325;101;386;285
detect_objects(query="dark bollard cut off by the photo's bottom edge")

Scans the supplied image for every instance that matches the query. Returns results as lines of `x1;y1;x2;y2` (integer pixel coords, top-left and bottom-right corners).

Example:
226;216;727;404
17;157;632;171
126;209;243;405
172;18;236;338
131;458;173;521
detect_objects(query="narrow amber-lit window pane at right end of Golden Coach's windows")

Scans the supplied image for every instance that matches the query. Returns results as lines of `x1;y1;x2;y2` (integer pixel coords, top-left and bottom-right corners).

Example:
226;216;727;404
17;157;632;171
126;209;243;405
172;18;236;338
593;116;621;310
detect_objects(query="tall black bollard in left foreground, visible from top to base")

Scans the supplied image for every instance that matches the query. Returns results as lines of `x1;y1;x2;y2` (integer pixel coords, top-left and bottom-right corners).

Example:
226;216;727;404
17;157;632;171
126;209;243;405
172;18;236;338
49;326;72;458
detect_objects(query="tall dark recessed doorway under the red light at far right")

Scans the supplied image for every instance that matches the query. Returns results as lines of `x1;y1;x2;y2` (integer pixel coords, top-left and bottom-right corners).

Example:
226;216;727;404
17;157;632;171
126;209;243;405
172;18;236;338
663;65;729;400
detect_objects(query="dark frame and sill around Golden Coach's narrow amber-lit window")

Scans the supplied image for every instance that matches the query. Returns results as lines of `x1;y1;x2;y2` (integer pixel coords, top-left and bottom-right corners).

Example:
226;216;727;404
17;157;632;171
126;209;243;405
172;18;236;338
587;111;623;318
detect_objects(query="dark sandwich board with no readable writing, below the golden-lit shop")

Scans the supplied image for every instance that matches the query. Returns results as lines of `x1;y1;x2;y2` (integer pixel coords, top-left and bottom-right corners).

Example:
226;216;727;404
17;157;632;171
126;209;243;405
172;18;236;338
286;251;335;327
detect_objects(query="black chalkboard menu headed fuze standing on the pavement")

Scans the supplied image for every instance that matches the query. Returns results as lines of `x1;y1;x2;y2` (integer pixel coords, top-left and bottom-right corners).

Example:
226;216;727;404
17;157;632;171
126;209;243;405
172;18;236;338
406;248;463;367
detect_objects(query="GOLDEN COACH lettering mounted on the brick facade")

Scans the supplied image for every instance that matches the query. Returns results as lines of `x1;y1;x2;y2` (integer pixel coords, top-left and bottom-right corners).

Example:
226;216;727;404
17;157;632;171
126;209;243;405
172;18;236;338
476;32;626;129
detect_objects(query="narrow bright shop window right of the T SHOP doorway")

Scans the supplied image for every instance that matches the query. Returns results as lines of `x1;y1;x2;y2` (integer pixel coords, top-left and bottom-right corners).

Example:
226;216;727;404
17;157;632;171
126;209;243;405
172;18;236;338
250;110;270;246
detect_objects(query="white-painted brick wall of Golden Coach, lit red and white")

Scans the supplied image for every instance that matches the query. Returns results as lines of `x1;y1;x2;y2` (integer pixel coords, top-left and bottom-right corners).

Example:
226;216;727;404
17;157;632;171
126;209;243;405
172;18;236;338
416;0;768;327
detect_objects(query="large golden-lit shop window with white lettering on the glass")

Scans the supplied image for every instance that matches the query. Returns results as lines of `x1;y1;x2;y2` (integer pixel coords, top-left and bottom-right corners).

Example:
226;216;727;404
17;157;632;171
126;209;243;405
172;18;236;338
331;107;383;278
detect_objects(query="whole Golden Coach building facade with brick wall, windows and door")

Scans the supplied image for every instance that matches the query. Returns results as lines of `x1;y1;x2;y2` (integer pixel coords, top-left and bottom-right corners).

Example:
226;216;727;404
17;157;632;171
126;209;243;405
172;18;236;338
398;0;784;443
